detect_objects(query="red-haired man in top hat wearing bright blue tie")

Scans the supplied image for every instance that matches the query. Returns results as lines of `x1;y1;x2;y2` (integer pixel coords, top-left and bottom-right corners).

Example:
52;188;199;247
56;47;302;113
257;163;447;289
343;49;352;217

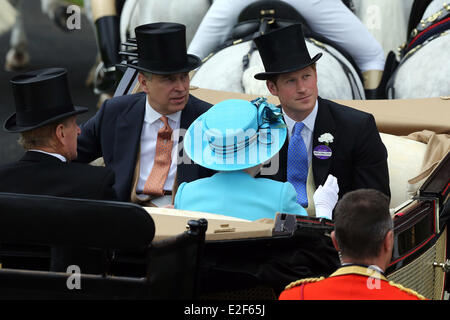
251;24;390;215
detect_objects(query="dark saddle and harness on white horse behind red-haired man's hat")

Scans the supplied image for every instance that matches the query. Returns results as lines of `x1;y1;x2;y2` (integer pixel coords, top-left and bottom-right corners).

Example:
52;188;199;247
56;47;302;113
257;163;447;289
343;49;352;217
203;0;362;99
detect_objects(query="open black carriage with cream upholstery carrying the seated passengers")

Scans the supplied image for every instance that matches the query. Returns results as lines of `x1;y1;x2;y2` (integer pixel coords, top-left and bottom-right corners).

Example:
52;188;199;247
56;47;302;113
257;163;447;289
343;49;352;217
0;65;450;300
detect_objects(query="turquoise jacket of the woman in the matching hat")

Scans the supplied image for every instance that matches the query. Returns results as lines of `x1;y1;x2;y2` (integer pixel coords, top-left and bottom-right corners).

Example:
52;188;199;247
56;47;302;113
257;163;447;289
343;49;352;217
174;170;307;220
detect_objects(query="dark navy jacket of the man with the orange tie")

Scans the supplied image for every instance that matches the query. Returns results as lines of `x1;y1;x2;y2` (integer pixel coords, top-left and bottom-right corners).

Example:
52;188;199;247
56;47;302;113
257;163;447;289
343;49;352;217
76;92;214;201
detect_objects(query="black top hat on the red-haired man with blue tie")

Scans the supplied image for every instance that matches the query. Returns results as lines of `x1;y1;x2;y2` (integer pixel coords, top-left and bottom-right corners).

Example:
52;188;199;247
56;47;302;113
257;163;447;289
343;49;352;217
254;23;322;80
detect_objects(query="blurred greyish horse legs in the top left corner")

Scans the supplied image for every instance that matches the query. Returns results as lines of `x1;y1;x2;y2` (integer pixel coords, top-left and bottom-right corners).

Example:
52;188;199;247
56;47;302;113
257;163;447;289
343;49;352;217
5;0;89;71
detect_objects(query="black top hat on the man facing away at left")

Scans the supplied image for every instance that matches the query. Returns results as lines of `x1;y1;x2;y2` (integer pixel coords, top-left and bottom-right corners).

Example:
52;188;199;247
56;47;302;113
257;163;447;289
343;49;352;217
3;68;88;132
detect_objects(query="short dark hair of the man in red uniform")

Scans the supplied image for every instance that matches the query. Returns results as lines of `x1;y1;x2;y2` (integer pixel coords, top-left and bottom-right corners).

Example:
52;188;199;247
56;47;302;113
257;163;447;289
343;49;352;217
334;189;393;259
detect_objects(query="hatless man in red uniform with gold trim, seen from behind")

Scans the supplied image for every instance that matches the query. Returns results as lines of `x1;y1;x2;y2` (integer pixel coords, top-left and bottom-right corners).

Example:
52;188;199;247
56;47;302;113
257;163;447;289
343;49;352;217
279;189;425;300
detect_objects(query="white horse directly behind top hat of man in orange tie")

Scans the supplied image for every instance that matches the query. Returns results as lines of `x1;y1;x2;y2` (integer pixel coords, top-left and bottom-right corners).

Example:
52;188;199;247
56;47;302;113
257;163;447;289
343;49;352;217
120;0;211;46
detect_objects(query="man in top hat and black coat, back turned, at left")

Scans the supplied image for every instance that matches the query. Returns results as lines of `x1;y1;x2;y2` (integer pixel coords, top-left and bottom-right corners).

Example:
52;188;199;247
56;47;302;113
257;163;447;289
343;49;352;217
0;68;117;272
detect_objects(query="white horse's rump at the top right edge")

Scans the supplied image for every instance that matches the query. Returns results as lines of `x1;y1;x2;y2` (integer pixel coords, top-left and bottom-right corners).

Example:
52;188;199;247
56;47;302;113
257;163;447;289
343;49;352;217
388;0;450;99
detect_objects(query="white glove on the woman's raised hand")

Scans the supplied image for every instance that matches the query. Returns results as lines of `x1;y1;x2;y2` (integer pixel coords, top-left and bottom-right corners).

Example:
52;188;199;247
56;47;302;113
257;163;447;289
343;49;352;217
313;174;339;220
